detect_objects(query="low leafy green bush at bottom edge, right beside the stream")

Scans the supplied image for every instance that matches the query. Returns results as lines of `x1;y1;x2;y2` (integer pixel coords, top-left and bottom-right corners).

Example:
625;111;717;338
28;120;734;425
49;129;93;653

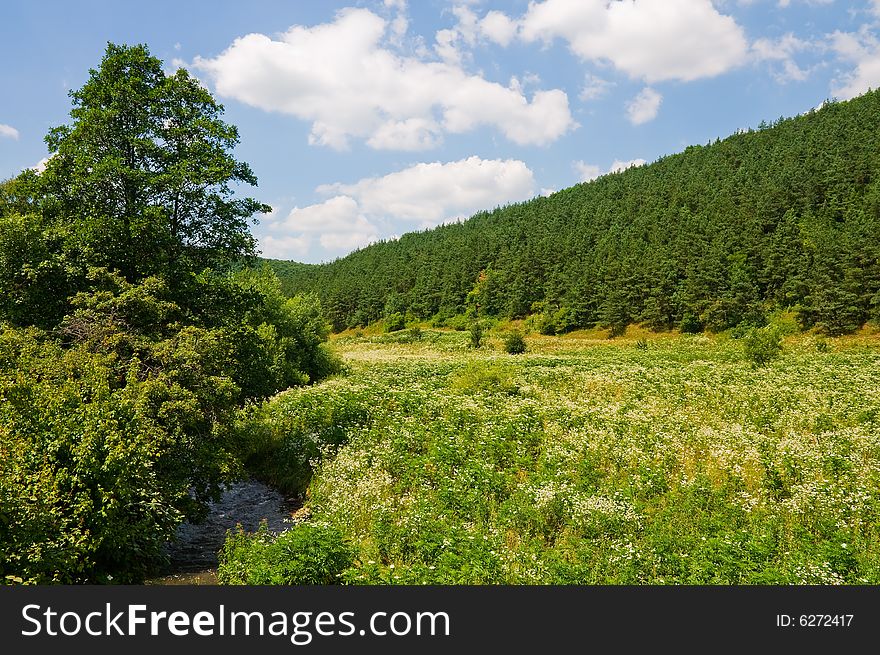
217;523;354;585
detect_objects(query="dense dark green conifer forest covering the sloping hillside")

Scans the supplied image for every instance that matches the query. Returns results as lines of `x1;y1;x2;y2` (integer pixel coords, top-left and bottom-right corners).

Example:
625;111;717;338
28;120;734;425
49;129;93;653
271;91;880;335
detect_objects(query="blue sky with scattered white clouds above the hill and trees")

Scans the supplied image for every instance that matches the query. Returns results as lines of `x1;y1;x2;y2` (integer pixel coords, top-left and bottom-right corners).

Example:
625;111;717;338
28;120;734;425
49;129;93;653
0;0;880;262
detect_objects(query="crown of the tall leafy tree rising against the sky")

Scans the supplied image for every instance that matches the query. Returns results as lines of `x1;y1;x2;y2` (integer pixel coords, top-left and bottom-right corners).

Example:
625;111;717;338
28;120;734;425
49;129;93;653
40;44;270;281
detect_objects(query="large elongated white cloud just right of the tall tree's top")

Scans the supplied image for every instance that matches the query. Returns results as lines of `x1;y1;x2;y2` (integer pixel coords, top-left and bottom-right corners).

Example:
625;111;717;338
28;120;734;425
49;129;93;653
193;3;576;150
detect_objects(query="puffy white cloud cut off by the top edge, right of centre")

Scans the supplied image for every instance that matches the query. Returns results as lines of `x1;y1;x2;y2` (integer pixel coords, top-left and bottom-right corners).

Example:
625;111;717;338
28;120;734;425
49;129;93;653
520;0;748;83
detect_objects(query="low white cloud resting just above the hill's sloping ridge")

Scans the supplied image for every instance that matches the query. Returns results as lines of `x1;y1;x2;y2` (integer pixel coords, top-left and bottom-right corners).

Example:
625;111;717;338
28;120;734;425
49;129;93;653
261;157;535;259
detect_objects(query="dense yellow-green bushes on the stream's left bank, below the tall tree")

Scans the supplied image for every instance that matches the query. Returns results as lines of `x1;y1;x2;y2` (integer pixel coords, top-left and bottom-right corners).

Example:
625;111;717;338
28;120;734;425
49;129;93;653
0;329;219;583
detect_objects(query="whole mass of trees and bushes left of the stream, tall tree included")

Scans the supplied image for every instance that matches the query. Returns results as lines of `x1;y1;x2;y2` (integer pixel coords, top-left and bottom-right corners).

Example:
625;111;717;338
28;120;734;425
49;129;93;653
0;44;336;583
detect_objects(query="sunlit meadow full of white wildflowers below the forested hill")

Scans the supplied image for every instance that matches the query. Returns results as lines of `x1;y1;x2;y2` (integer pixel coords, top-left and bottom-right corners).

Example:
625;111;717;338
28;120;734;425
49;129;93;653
220;333;880;584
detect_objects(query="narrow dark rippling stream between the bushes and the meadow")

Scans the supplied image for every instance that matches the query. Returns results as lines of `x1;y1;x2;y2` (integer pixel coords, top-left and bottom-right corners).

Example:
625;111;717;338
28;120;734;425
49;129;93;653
148;480;299;585
